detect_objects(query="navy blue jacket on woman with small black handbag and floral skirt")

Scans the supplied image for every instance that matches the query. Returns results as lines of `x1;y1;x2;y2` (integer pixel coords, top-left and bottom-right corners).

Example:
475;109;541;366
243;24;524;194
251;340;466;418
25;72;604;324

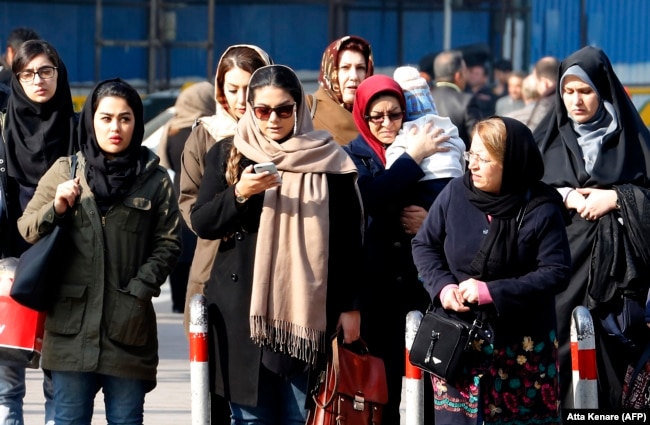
413;177;571;343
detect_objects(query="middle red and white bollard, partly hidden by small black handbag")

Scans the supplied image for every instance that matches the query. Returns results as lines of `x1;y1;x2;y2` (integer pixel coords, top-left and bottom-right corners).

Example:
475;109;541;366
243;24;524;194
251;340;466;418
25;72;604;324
400;310;424;425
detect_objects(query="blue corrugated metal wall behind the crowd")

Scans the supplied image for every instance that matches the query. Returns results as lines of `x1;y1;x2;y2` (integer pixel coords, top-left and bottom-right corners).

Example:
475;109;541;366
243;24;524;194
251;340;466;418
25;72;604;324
0;0;650;90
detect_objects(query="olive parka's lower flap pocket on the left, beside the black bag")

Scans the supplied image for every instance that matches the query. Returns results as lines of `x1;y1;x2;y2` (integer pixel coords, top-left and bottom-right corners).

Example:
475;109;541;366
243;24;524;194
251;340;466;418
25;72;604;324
45;285;87;335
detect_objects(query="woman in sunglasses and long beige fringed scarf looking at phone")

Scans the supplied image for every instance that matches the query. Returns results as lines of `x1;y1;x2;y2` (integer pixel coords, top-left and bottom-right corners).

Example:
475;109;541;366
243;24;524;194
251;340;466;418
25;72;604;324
191;65;363;425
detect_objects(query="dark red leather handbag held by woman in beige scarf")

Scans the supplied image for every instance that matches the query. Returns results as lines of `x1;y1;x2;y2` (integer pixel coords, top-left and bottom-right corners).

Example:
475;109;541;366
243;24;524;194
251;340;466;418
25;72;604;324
307;334;388;425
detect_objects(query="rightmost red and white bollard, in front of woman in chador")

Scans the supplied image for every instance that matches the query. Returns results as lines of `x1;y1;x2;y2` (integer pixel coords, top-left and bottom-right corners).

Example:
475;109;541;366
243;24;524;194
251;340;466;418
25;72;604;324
567;306;598;409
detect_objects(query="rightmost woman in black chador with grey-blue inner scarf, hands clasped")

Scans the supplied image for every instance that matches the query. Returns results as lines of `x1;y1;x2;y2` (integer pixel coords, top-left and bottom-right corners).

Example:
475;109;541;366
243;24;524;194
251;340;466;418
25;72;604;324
539;47;650;408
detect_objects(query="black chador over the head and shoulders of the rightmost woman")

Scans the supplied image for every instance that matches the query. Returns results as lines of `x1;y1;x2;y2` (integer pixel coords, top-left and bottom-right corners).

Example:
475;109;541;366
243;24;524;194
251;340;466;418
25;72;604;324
540;46;650;188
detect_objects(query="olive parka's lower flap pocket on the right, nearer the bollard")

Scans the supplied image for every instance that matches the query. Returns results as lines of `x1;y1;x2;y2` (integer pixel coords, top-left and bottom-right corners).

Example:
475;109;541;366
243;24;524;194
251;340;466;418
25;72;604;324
106;290;155;347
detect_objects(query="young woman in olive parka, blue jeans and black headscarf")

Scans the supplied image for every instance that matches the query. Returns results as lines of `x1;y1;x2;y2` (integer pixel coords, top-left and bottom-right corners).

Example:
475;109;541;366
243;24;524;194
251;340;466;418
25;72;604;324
18;79;181;425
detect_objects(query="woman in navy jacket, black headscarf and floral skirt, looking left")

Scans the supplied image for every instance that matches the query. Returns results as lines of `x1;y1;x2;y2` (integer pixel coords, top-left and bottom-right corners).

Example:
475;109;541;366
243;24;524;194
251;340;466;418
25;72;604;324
412;117;570;425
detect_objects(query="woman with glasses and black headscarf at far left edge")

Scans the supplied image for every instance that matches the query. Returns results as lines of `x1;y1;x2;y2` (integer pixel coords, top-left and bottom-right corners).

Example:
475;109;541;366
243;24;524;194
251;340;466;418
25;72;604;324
0;40;75;422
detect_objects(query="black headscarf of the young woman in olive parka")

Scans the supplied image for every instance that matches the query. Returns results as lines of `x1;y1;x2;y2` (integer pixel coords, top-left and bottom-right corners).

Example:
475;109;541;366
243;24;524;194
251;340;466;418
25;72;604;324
77;78;146;213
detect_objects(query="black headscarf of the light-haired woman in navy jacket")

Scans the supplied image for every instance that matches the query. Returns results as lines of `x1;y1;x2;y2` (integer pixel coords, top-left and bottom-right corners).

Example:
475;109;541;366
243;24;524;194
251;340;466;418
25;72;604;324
463;117;562;280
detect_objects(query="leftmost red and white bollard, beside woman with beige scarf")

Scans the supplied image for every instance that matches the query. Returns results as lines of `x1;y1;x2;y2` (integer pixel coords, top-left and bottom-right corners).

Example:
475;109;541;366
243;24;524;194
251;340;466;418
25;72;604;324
189;294;210;425
